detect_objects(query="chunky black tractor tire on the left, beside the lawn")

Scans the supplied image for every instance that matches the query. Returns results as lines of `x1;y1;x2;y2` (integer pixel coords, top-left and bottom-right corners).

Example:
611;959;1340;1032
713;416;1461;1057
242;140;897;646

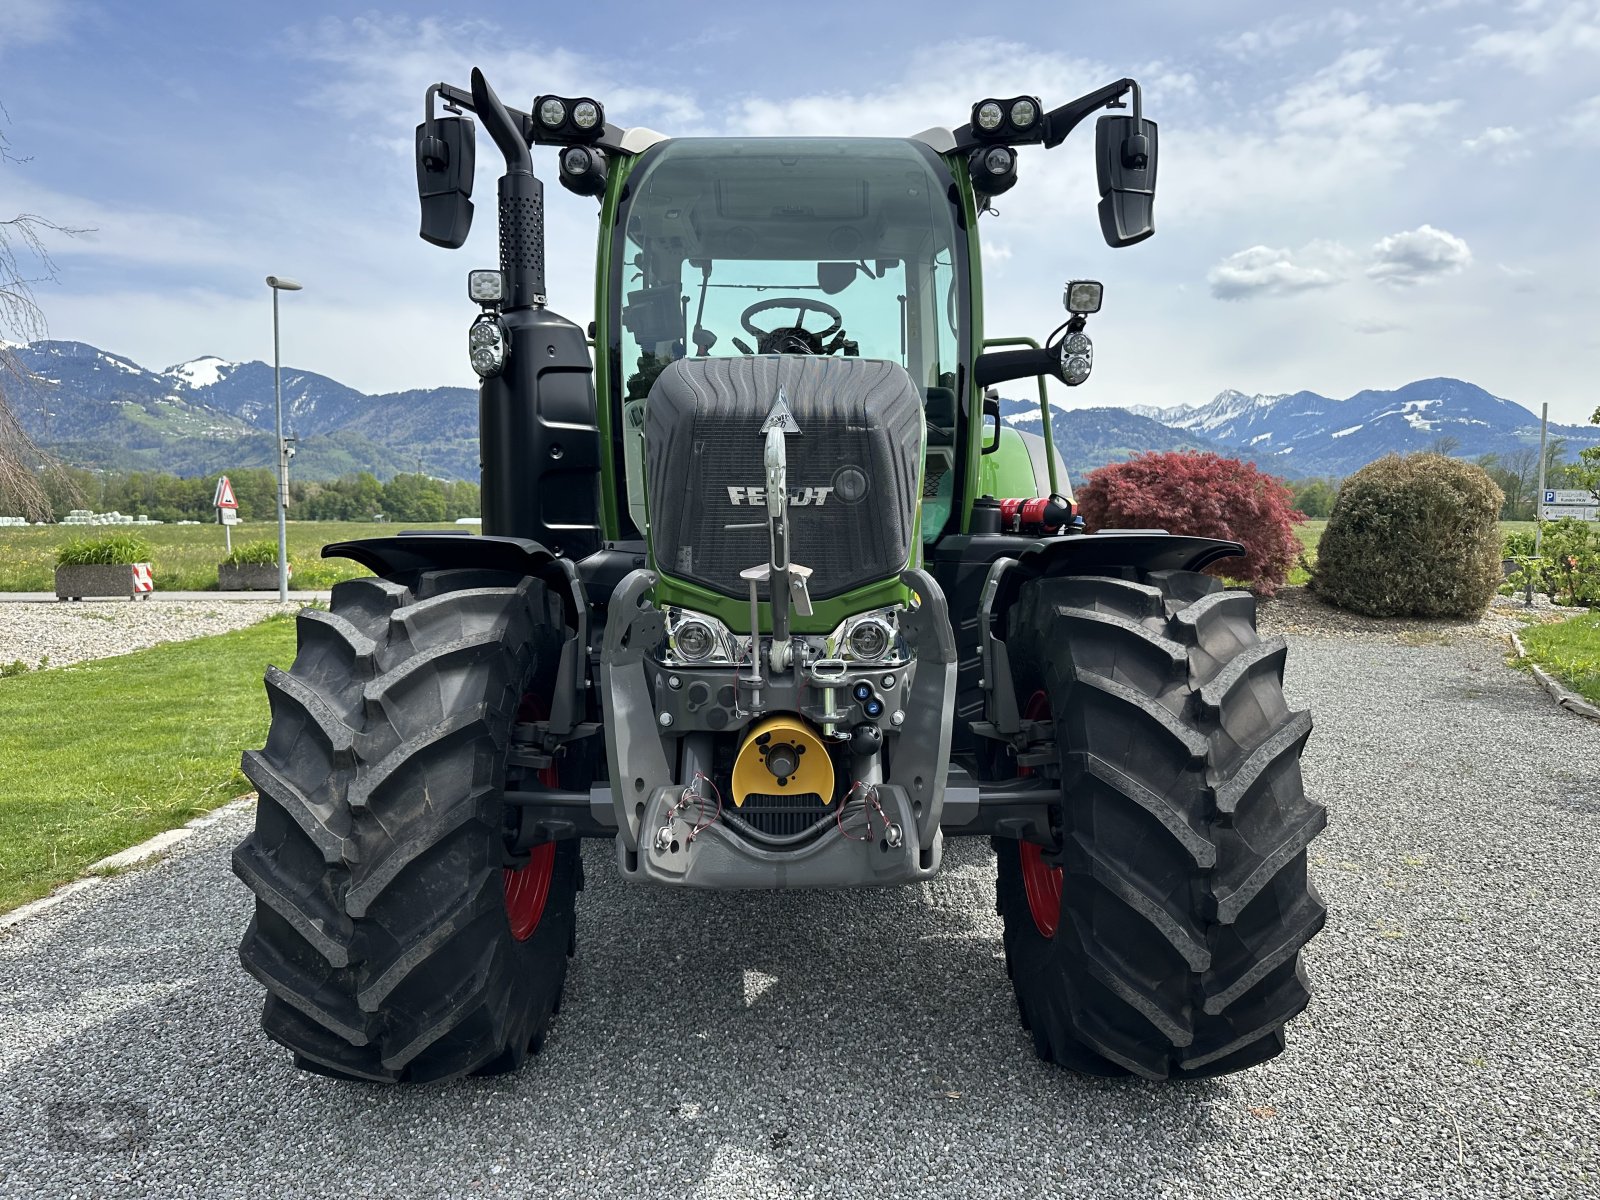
234;570;581;1083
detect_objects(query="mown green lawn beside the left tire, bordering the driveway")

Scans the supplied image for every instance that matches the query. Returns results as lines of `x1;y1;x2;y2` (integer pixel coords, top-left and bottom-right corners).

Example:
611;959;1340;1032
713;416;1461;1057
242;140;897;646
0;616;294;912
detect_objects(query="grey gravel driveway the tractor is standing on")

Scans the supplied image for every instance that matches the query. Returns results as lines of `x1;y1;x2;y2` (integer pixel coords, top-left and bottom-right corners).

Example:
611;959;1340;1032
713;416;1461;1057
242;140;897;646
0;624;1600;1197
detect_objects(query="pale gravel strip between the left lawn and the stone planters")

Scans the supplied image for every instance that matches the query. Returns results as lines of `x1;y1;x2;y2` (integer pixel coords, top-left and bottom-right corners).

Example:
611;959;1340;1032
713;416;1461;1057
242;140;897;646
0;600;304;667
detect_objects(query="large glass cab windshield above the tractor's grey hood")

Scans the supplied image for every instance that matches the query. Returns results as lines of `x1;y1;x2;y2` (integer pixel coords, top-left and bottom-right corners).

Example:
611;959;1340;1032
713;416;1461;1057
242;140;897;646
610;138;968;534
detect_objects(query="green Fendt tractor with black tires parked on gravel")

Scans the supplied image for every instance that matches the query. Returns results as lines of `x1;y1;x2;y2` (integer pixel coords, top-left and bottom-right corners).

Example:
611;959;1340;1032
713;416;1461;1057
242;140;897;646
234;70;1326;1082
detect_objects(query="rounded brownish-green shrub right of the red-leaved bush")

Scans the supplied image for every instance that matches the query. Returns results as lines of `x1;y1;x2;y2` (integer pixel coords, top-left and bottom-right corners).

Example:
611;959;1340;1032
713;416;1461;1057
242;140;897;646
1312;454;1504;618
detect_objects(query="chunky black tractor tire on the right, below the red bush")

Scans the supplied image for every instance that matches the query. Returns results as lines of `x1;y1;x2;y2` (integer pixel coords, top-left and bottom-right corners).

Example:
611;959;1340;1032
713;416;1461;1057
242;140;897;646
995;570;1326;1080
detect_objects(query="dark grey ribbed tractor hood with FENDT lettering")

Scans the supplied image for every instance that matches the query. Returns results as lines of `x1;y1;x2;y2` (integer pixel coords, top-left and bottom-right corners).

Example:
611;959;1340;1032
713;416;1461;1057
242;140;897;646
645;355;923;600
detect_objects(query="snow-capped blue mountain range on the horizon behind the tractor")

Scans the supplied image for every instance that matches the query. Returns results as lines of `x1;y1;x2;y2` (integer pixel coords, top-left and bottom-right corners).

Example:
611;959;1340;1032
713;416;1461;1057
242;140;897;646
8;341;1600;480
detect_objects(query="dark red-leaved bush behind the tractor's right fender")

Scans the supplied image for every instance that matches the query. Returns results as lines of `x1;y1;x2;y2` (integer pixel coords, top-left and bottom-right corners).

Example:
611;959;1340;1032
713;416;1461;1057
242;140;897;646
1075;453;1306;595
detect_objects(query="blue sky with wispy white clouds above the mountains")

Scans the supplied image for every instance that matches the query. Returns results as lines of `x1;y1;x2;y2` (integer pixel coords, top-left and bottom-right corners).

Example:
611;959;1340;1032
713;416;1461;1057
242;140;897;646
0;0;1600;422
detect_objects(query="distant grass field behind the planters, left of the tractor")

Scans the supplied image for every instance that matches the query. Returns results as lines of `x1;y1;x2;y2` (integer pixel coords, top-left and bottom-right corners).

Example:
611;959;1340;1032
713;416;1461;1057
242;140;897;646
0;522;461;592
